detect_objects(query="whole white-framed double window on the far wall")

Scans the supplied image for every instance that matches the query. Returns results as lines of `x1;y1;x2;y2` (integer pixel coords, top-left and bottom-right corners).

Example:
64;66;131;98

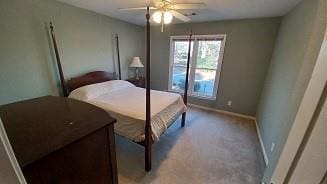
168;35;226;99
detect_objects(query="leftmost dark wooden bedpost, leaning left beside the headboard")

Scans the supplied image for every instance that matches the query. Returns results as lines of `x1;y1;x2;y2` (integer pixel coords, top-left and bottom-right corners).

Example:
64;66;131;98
50;22;68;97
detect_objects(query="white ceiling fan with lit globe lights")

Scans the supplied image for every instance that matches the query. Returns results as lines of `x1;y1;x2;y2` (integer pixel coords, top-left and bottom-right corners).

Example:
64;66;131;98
119;0;206;32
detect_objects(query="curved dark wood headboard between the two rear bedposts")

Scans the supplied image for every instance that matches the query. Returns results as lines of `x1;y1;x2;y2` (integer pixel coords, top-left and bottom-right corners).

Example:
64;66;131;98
66;71;116;94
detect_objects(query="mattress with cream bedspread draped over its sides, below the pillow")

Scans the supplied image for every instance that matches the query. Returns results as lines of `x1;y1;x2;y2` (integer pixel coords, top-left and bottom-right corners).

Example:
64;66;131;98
69;80;186;142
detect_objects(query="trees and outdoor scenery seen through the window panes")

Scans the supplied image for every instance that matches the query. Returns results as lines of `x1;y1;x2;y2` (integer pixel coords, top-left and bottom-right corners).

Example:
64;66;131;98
172;40;221;97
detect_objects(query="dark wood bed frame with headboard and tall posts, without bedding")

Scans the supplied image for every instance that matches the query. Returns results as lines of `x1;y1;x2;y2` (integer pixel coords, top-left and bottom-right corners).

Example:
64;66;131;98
50;8;192;171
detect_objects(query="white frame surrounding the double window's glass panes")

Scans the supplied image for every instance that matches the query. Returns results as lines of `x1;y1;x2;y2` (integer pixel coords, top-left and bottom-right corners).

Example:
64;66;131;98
168;34;227;100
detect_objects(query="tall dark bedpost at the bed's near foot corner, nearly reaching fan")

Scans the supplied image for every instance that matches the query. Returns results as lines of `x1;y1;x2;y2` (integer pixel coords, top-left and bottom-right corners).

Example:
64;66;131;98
145;7;152;171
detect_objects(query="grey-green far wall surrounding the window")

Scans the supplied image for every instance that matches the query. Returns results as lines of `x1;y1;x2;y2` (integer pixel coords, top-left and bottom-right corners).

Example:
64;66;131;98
151;18;280;116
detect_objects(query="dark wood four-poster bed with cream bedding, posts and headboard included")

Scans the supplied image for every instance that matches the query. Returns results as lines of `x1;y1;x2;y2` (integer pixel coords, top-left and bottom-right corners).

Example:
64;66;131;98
51;8;192;171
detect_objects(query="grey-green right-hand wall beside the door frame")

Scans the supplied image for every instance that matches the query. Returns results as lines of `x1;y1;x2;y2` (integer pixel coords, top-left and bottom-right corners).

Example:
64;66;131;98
257;0;327;182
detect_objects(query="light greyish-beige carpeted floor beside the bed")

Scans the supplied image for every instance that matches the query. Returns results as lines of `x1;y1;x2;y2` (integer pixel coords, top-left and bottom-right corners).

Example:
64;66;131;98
116;108;264;184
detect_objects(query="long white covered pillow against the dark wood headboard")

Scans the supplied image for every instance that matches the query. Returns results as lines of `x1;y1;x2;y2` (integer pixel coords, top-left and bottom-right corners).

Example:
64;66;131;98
69;80;135;101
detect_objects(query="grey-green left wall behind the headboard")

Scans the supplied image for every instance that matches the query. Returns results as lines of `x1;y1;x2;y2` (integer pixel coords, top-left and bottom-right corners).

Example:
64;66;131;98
0;0;144;104
